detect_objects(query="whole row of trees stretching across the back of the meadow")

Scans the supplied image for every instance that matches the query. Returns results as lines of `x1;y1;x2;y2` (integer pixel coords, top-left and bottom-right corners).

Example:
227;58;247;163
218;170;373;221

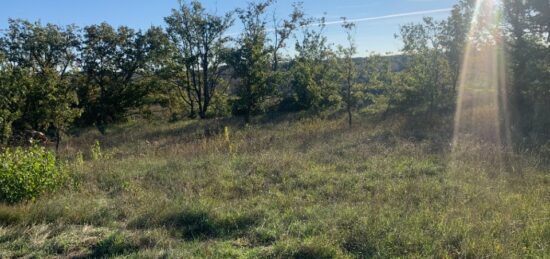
0;0;550;148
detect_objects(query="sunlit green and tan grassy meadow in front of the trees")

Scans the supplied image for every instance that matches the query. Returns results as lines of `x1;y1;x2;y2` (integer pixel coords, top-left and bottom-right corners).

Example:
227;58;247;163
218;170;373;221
0;116;550;258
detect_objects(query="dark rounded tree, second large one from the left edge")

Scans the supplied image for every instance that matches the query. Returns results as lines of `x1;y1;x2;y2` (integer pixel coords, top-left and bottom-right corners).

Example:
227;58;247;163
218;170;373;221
79;23;162;133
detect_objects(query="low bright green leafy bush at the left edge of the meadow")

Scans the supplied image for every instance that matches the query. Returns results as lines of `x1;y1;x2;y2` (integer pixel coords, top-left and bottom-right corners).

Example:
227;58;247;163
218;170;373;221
0;147;67;203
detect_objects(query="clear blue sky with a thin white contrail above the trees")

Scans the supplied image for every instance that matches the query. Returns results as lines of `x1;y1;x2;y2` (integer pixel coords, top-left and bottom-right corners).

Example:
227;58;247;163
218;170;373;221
0;0;457;54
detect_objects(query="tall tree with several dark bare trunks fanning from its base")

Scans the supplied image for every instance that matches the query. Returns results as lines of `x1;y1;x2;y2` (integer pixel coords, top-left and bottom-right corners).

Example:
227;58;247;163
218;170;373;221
165;0;233;119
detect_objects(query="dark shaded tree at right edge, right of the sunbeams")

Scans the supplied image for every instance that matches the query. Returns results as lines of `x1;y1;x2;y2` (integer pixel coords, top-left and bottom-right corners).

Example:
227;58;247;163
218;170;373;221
502;0;550;144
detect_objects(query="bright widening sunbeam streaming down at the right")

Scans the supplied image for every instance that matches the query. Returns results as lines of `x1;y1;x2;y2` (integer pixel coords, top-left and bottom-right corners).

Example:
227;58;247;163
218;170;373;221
453;0;510;169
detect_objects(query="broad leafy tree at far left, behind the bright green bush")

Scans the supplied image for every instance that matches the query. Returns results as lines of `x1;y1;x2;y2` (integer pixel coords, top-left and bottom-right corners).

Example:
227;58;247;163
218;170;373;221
2;20;80;147
